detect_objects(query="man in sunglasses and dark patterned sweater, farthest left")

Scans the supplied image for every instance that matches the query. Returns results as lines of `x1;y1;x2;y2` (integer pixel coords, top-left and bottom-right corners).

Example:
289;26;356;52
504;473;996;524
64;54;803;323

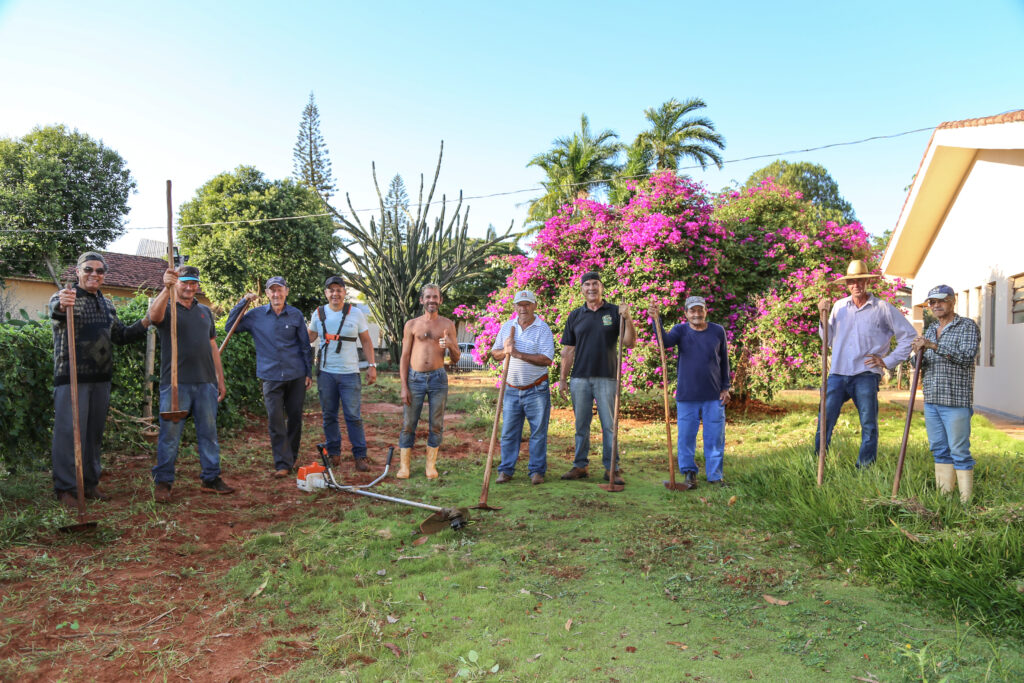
49;252;150;509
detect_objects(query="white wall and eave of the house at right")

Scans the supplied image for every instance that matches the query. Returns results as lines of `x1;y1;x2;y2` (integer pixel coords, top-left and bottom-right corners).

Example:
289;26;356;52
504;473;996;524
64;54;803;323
913;150;1024;421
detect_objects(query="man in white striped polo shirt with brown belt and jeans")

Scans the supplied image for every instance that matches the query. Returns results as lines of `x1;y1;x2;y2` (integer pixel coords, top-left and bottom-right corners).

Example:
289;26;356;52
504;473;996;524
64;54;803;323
490;290;555;484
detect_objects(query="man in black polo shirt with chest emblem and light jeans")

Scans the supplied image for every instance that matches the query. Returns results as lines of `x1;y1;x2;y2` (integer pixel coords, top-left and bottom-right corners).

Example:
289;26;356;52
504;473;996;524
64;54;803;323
558;272;637;483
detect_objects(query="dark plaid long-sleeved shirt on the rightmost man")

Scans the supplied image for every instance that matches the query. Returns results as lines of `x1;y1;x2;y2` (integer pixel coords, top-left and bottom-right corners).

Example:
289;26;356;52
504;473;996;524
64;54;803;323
922;315;981;408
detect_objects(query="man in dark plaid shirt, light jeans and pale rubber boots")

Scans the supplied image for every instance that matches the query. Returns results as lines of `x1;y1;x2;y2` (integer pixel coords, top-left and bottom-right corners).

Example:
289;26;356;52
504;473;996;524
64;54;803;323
911;285;980;503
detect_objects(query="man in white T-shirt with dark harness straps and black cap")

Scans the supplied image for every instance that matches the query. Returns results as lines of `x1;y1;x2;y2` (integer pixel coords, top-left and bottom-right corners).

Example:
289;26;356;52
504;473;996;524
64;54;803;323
309;275;377;472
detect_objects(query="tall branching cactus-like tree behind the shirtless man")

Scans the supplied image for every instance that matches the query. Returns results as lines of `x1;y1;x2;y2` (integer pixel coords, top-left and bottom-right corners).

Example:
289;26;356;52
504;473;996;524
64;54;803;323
329;142;512;360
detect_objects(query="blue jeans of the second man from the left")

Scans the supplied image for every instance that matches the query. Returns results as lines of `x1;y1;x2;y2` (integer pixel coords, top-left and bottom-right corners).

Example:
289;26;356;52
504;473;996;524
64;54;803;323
153;383;220;483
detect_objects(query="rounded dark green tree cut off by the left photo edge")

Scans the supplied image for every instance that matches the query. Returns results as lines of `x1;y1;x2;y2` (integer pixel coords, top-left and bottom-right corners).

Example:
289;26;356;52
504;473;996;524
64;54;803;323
0;126;135;282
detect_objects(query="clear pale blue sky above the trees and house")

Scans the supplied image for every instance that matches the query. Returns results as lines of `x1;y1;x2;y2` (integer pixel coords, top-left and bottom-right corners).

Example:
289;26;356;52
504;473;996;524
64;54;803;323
0;0;1024;252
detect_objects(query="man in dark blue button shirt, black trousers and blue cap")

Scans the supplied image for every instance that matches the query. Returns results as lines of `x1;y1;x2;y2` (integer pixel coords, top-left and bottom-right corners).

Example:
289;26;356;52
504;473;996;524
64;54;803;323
225;275;313;478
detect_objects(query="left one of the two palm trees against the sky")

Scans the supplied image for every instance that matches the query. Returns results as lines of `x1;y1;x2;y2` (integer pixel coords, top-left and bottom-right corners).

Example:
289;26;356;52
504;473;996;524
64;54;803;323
526;114;622;224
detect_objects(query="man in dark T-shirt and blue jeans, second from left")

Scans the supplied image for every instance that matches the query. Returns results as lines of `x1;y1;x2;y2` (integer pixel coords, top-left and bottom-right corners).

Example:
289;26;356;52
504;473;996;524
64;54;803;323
150;265;234;503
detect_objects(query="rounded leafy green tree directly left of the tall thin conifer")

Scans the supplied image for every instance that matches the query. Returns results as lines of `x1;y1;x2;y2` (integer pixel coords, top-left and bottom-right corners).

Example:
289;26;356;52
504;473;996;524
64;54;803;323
178;166;340;312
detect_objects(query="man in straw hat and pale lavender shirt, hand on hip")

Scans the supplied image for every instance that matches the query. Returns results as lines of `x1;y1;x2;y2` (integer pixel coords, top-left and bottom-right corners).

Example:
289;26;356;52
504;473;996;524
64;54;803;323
814;260;918;468
